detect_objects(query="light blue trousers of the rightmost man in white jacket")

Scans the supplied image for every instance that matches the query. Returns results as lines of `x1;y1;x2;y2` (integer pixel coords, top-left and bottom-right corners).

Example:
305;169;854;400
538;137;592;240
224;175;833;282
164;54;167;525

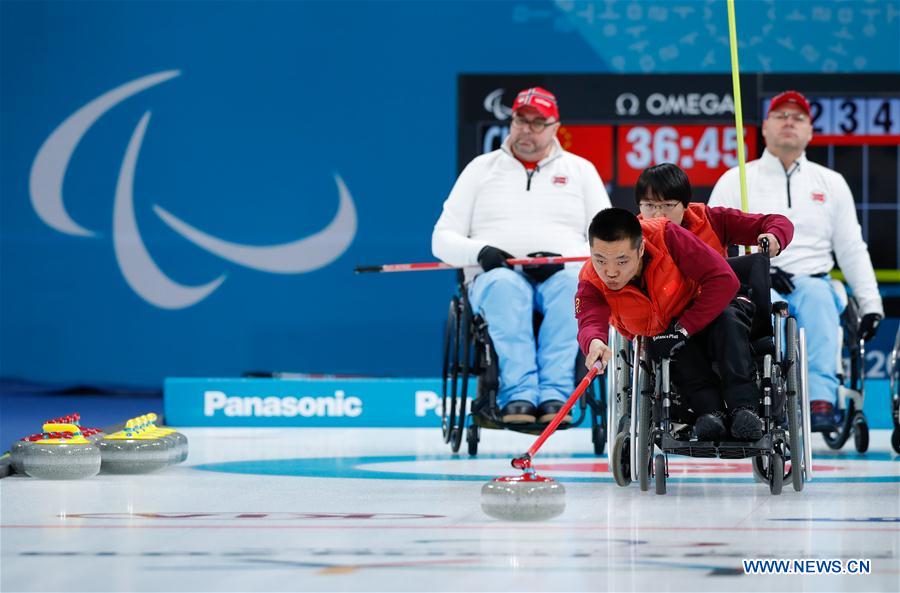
772;276;843;405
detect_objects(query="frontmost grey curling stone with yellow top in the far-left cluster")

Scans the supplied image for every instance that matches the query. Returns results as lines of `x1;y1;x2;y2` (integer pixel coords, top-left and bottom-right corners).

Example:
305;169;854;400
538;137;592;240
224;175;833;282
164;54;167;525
21;424;100;480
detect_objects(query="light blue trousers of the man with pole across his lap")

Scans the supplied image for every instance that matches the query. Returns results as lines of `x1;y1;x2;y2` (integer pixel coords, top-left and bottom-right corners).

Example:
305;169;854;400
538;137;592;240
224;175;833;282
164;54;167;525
469;268;578;407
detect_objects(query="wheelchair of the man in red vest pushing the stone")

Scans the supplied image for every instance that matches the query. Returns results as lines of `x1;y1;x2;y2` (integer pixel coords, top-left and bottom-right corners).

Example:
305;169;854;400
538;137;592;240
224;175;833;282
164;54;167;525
607;253;812;495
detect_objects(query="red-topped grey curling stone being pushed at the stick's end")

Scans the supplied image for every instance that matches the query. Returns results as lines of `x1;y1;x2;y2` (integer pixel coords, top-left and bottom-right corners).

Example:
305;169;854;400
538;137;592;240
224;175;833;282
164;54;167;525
481;471;566;521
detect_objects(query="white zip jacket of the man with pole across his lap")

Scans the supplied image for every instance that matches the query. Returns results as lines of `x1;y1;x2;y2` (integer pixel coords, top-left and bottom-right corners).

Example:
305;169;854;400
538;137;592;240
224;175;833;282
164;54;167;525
431;140;611;266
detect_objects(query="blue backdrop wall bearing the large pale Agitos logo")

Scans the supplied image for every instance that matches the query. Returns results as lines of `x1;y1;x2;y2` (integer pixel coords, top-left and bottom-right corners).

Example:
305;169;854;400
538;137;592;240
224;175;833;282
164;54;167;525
0;0;900;384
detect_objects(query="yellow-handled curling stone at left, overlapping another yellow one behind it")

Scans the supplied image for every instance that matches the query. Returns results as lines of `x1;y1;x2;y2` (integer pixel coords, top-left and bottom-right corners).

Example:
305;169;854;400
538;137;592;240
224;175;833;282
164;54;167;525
97;419;169;474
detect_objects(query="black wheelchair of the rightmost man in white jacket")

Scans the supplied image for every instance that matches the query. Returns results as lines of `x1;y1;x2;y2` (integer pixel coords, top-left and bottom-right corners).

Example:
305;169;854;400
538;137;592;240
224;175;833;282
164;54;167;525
822;280;869;453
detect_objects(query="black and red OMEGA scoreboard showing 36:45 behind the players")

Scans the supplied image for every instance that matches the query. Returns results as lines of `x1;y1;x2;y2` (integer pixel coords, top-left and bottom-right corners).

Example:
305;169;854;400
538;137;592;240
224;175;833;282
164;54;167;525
457;74;900;286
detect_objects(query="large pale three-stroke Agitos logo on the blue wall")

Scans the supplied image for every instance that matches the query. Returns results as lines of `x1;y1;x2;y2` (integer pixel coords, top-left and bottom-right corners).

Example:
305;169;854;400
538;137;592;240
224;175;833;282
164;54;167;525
29;70;356;309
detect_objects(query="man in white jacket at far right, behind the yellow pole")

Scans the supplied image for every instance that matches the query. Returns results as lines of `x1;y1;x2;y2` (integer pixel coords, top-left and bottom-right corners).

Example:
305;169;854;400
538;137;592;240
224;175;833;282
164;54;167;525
709;91;884;431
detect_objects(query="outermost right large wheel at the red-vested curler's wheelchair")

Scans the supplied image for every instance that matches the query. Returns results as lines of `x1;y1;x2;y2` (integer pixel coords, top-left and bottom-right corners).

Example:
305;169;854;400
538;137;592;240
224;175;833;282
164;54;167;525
788;317;809;494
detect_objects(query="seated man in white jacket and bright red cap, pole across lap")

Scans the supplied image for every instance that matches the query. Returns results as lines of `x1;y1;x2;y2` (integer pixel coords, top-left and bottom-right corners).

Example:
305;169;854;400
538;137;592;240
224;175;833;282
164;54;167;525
431;88;611;423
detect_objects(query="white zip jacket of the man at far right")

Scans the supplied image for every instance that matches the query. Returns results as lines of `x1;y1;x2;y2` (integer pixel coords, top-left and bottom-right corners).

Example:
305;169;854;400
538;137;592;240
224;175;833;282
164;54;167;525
709;150;884;315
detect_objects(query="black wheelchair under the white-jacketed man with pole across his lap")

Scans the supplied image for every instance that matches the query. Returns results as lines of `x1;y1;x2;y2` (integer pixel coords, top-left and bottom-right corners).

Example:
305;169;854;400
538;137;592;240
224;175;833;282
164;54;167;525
441;273;606;456
